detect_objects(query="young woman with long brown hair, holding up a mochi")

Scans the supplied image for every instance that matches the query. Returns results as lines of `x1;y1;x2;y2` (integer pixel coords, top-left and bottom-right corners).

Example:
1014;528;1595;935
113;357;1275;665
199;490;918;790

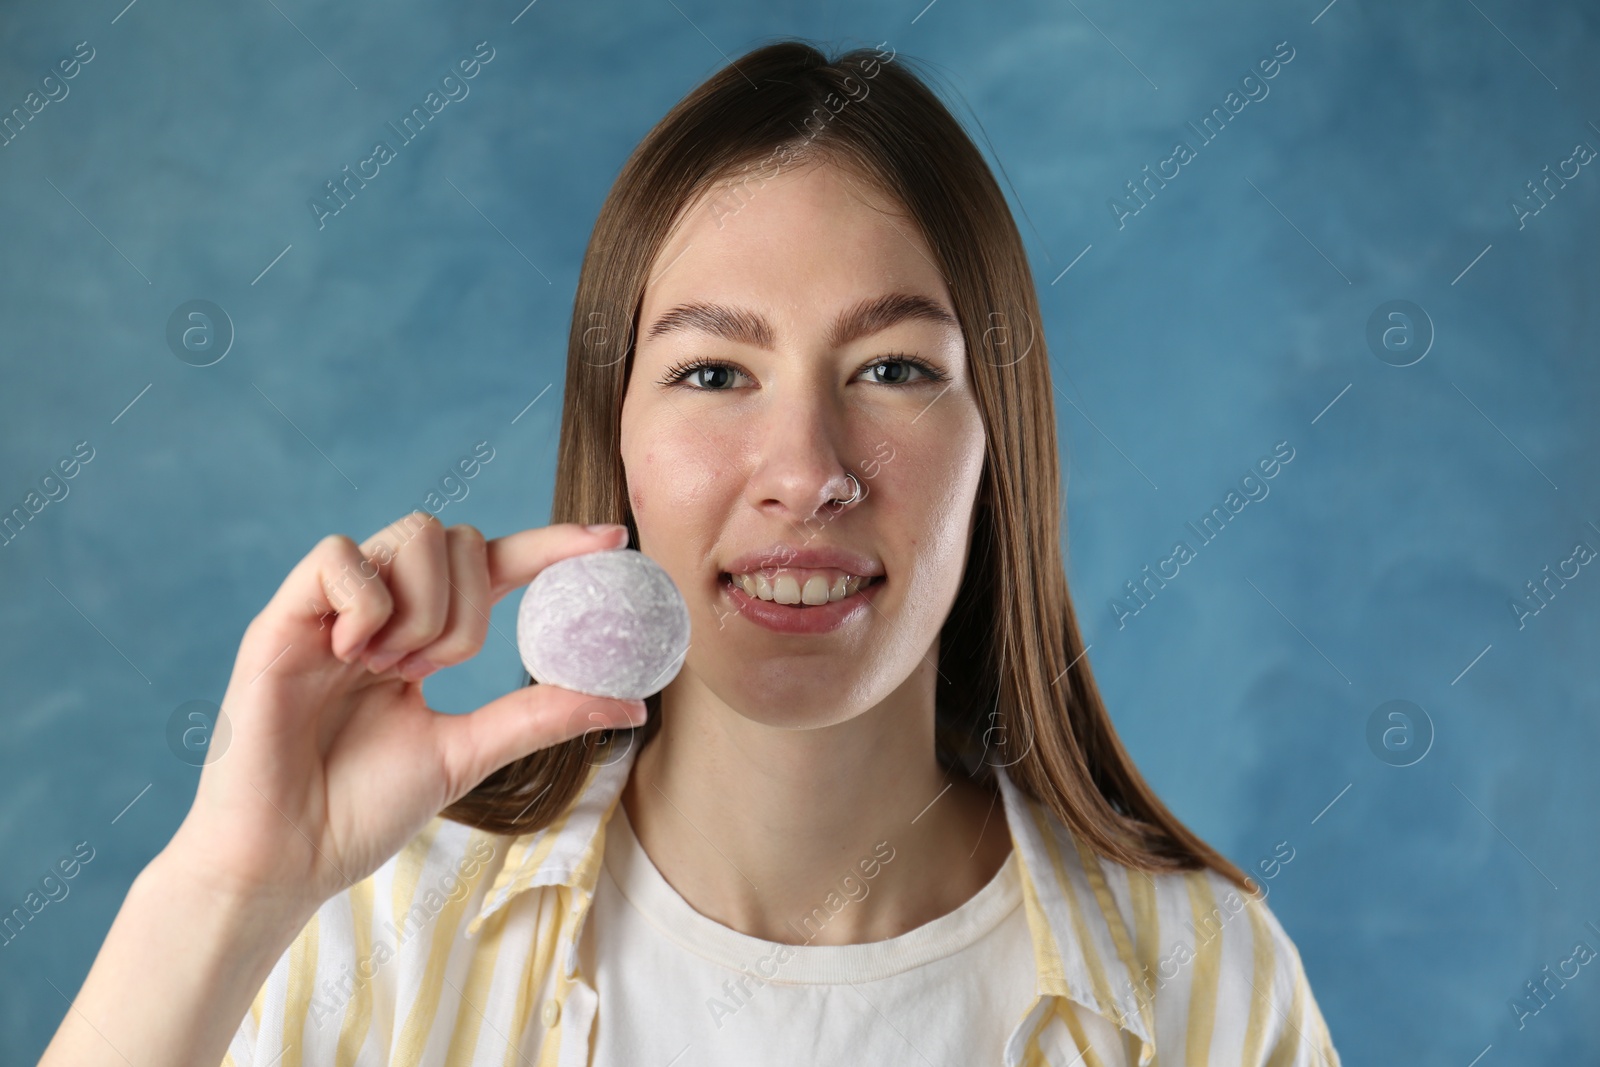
45;42;1338;1067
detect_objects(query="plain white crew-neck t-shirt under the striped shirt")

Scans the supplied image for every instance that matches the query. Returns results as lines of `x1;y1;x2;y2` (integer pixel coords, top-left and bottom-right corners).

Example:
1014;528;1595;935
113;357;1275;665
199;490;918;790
579;803;1037;1067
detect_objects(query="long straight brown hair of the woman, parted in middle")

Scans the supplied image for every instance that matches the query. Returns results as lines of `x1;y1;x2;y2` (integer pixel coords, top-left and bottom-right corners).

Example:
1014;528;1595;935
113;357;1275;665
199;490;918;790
443;40;1251;891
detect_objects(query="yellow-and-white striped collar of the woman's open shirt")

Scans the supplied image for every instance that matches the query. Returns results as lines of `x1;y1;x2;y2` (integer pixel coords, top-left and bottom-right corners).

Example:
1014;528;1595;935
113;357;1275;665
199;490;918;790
467;745;1155;1067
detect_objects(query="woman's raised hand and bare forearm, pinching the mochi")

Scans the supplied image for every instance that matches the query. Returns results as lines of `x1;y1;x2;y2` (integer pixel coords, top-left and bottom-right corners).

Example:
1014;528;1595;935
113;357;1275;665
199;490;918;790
40;512;645;1067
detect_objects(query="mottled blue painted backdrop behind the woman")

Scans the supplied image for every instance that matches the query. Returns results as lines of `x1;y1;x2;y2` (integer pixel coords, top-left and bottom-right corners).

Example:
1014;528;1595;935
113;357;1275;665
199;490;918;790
0;0;1600;1067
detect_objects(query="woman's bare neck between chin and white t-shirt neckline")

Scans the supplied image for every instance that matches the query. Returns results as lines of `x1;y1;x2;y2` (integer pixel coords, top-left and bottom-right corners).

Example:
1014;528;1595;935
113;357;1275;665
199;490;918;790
622;669;1011;945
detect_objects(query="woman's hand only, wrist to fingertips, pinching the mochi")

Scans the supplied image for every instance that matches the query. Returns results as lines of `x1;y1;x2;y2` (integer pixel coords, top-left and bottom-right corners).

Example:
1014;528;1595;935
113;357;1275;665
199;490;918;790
163;512;645;920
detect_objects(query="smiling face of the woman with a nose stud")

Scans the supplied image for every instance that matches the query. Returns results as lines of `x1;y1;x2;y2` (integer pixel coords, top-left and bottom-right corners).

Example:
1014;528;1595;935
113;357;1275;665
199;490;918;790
621;165;984;726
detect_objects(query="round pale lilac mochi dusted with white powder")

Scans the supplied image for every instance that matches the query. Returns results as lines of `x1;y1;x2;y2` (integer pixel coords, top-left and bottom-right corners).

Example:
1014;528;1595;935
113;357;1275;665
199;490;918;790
517;547;690;701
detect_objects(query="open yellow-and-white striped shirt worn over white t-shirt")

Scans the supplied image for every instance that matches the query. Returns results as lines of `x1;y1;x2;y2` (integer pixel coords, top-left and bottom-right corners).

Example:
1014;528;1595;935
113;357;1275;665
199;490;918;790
222;747;1339;1067
